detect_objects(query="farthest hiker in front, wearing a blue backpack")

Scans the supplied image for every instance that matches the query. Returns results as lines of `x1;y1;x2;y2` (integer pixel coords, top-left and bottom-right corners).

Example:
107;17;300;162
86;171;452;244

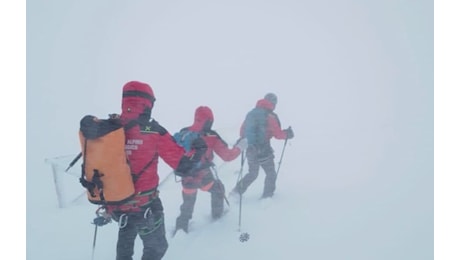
230;93;294;198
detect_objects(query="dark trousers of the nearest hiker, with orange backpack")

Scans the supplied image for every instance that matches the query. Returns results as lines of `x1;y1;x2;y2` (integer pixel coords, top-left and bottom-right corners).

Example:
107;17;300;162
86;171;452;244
116;198;168;260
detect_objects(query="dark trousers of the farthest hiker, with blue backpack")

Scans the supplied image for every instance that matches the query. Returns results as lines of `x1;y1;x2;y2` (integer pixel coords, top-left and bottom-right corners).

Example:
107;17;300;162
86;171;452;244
235;145;276;197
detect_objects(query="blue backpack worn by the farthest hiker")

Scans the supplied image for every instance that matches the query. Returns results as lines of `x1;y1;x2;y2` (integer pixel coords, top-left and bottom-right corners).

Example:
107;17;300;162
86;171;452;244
243;107;269;145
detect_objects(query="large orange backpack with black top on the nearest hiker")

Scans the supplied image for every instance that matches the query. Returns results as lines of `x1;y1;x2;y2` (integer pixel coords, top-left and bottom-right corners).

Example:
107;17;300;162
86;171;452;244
79;115;135;205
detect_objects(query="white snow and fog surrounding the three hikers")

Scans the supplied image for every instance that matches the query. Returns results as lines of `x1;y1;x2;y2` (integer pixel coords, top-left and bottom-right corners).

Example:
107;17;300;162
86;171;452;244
21;0;434;260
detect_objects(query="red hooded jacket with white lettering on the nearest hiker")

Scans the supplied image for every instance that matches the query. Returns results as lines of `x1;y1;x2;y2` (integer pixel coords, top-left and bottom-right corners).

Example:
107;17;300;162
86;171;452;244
121;81;189;192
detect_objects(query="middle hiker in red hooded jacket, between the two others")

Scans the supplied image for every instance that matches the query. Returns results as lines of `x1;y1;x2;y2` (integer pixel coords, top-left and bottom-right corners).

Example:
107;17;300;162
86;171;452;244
174;106;247;233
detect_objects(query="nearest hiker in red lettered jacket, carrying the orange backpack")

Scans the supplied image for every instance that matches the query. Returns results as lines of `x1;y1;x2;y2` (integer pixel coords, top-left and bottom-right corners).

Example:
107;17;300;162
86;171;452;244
106;81;206;260
